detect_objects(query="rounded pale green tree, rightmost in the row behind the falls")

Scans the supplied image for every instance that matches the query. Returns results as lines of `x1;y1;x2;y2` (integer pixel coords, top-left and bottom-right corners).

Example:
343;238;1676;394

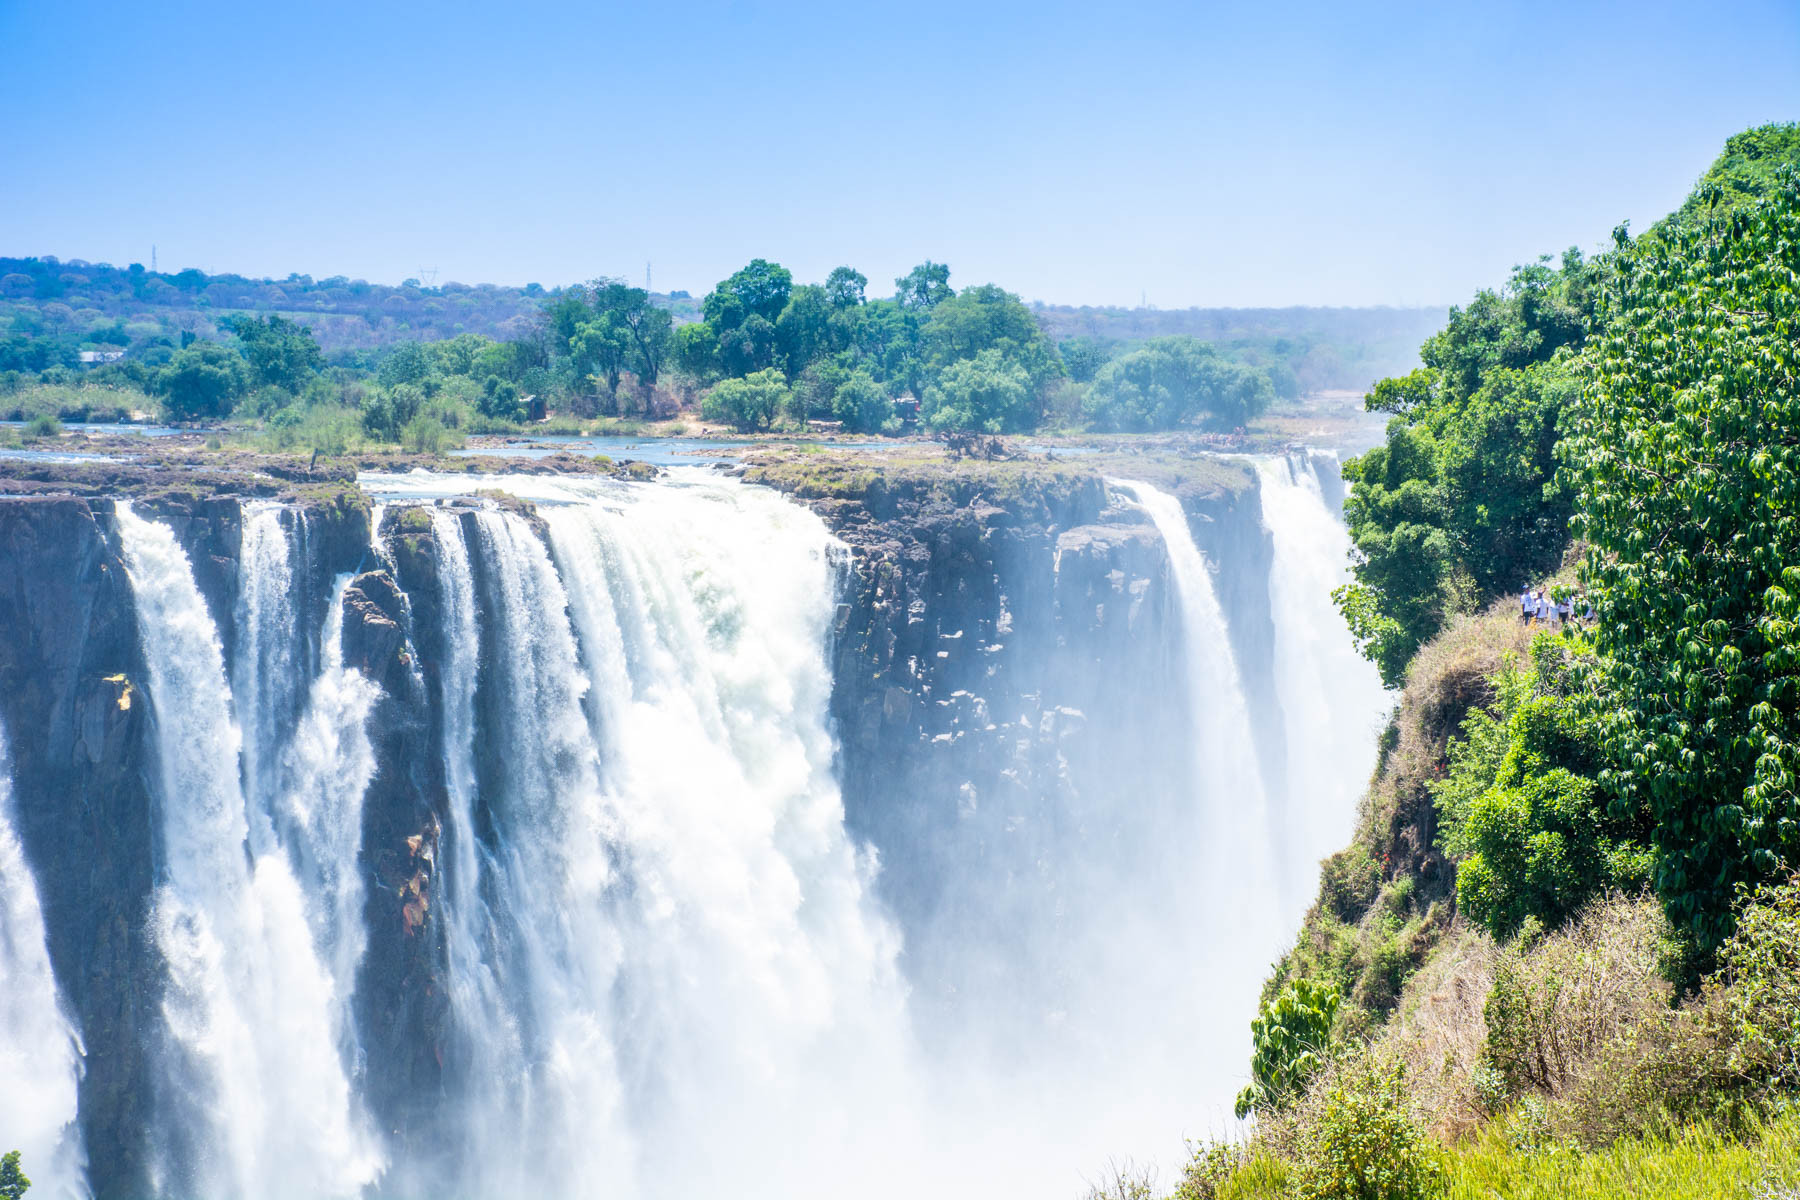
1087;336;1274;430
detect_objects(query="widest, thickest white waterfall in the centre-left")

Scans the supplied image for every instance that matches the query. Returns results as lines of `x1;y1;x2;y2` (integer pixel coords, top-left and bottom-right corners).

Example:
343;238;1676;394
401;484;911;1196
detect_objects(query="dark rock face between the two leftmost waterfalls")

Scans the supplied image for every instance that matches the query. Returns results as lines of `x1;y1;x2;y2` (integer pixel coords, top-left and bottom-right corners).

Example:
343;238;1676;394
0;498;160;1196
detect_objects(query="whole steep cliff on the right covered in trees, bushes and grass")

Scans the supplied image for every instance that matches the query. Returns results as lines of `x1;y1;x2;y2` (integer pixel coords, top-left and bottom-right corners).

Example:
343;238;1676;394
1144;126;1800;1198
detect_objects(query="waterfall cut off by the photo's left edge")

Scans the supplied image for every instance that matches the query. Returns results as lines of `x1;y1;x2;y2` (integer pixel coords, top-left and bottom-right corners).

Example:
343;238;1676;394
0;730;88;1200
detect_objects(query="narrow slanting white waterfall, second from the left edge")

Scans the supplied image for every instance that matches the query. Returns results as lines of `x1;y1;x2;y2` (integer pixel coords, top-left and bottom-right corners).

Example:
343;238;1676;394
117;504;380;1200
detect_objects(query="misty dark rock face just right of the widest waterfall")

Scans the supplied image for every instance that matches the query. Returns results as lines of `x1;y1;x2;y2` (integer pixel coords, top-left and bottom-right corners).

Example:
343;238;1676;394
766;464;1280;1011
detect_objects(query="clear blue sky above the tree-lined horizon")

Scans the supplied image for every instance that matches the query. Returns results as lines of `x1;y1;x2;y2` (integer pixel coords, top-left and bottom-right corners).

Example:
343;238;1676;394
0;0;1800;308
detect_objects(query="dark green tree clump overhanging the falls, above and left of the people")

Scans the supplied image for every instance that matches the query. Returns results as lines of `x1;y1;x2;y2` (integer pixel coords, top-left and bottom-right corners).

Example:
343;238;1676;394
1334;250;1606;687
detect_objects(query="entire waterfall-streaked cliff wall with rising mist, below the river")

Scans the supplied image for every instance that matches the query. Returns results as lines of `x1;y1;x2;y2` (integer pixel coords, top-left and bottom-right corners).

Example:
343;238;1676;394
0;452;1388;1200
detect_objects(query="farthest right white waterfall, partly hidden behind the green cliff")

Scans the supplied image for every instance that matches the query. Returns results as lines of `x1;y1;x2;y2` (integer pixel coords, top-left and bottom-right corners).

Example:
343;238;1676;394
1256;453;1391;928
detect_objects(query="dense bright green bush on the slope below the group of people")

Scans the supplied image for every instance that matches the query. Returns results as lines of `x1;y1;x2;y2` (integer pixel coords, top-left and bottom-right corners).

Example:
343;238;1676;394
1431;633;1651;937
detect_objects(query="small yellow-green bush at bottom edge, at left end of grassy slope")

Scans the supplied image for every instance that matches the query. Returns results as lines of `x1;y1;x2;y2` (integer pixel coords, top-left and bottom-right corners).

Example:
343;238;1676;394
1294;1054;1444;1200
